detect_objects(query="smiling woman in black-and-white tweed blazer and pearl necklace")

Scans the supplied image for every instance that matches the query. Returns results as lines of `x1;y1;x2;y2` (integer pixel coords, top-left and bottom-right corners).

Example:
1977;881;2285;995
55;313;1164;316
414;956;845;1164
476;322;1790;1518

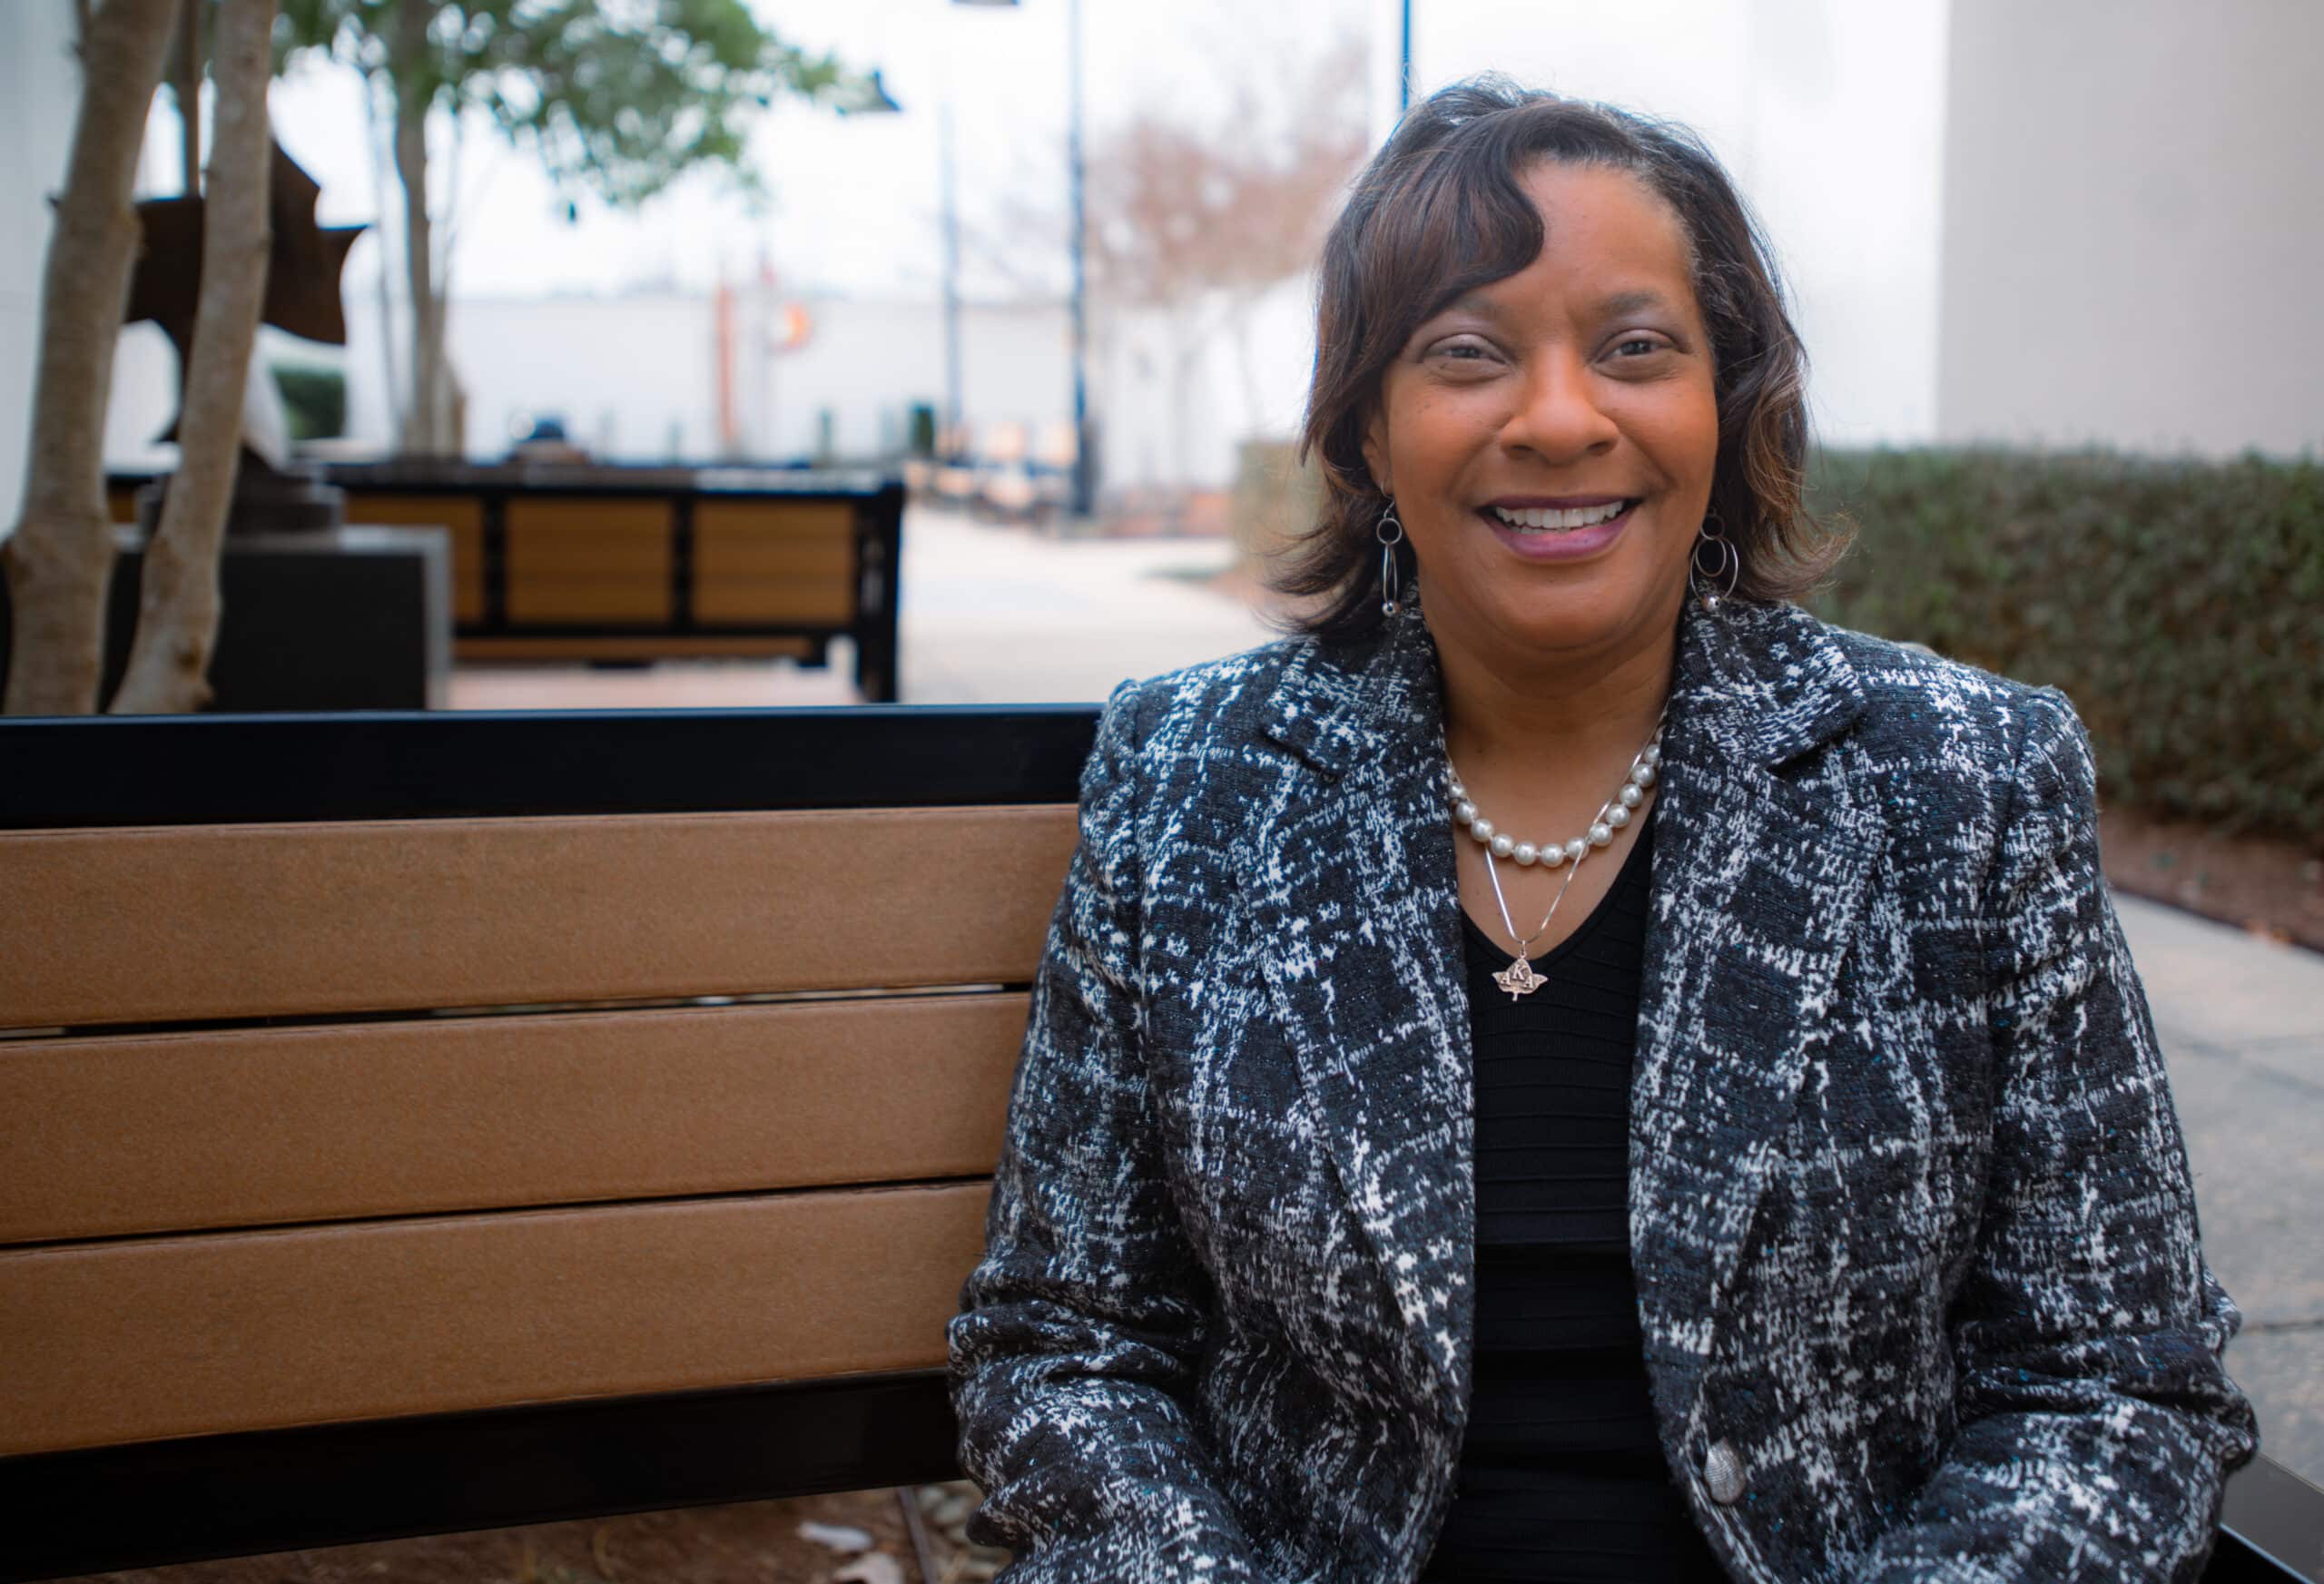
950;82;2257;1584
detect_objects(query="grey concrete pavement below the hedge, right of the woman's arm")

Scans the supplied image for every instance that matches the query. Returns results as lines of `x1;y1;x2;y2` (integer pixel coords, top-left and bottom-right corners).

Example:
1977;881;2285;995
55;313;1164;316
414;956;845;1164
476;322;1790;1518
2115;892;2324;1481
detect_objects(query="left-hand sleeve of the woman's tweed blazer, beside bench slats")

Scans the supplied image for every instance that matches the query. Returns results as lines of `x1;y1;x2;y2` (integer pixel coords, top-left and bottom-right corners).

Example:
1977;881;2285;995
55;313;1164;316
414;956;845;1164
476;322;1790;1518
948;683;1262;1584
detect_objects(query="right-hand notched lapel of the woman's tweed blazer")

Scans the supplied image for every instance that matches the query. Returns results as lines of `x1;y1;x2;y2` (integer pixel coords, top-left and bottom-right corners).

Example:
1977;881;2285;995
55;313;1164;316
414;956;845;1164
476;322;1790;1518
1630;602;1883;1422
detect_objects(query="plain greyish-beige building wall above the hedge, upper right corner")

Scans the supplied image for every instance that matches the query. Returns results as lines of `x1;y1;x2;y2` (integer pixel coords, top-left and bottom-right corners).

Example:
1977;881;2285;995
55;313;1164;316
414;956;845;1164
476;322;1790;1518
1938;0;2324;455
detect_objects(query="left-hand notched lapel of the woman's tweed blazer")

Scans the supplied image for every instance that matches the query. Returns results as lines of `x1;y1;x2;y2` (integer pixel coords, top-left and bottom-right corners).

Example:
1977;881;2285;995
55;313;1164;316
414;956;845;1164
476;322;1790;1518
1246;620;1476;1402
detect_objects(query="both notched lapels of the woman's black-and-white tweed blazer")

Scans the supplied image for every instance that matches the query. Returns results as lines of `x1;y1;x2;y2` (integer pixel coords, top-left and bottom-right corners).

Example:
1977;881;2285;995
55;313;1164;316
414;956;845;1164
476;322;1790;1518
1246;602;1877;1444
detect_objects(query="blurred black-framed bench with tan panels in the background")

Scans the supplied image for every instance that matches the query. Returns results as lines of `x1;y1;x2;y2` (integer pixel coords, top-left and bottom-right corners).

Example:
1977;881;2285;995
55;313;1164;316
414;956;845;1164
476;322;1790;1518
107;462;904;703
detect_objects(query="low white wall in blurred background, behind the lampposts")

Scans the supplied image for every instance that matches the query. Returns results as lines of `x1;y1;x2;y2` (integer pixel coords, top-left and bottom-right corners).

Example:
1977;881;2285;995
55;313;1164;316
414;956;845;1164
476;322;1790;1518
304;276;1313;487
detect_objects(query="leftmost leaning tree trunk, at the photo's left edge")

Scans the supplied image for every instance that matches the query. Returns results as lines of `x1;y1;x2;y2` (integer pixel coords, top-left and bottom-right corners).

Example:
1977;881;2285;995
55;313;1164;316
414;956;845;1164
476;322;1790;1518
0;0;177;715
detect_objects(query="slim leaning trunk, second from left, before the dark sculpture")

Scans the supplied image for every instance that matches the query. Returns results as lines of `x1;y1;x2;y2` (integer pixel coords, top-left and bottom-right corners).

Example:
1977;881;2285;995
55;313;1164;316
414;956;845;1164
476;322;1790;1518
113;0;277;715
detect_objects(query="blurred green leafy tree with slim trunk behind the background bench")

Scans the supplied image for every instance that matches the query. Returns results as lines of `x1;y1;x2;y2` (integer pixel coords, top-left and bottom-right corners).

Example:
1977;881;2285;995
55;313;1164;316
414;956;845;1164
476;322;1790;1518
277;0;879;453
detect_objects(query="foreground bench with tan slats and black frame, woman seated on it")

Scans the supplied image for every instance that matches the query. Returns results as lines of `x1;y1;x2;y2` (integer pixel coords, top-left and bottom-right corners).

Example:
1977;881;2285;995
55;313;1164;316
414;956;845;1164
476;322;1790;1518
0;706;2324;1584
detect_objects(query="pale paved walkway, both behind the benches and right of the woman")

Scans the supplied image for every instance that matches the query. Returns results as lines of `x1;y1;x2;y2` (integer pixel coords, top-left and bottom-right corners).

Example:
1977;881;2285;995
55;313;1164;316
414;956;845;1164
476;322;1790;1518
453;508;2324;1481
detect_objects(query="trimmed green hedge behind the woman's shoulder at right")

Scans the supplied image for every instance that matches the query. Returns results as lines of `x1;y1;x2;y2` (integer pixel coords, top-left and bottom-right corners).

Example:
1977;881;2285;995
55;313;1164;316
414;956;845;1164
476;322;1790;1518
1808;450;2324;852
